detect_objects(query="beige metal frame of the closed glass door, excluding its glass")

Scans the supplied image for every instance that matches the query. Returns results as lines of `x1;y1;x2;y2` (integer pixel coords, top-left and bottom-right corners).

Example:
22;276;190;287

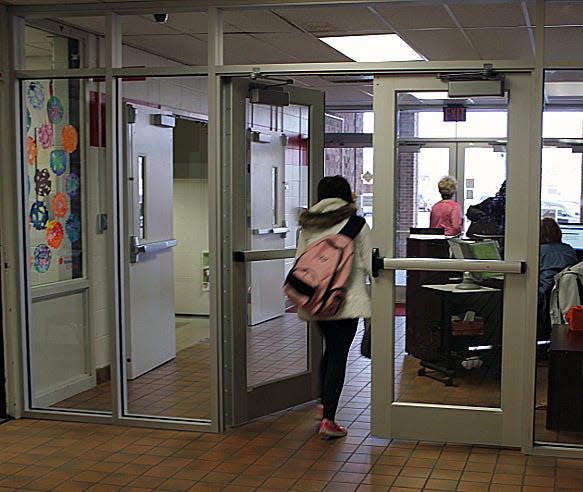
371;73;540;446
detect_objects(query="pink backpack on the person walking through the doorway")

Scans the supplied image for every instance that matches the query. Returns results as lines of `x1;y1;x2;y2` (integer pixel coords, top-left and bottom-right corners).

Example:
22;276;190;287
283;215;365;318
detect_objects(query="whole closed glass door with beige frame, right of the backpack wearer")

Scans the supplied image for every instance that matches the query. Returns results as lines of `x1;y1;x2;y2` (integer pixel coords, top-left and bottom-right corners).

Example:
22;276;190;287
372;76;529;445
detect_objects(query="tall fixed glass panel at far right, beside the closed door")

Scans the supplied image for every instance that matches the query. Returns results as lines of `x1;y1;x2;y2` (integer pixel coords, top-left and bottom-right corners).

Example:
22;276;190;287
534;68;583;445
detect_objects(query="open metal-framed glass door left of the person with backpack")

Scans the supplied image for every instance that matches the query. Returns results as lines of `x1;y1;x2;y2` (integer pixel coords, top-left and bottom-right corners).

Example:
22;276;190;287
223;79;324;425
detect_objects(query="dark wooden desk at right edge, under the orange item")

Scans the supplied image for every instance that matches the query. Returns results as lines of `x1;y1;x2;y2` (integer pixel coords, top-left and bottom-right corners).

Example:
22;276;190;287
547;325;583;431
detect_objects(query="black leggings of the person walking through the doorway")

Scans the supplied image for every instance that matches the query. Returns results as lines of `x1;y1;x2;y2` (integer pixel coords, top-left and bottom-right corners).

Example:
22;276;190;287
318;318;358;420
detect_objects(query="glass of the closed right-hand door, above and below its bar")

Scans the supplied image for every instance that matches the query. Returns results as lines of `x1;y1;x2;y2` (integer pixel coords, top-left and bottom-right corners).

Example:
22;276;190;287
394;94;506;407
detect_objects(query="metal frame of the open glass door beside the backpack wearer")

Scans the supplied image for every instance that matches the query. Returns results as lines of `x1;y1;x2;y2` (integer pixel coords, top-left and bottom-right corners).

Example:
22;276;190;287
220;76;324;425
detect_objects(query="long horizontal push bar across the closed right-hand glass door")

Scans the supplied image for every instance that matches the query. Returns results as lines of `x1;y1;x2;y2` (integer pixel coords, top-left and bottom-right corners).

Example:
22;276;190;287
372;248;526;277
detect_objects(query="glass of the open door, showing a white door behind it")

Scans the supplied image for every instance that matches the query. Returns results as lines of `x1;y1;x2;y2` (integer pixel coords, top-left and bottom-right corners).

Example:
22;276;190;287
247;98;309;386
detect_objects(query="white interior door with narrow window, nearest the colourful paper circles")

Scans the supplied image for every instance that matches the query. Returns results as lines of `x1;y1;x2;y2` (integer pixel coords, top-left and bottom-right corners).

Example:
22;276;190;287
125;105;176;379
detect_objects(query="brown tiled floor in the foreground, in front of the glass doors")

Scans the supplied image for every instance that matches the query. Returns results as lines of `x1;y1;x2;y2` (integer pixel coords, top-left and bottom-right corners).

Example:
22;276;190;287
0;392;583;492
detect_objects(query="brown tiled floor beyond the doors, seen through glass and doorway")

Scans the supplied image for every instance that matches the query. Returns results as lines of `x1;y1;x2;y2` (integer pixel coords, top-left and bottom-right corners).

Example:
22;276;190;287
52;313;583;444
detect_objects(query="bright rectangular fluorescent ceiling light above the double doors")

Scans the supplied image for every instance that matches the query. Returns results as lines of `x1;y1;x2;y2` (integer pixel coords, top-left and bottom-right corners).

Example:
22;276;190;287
320;34;423;62
